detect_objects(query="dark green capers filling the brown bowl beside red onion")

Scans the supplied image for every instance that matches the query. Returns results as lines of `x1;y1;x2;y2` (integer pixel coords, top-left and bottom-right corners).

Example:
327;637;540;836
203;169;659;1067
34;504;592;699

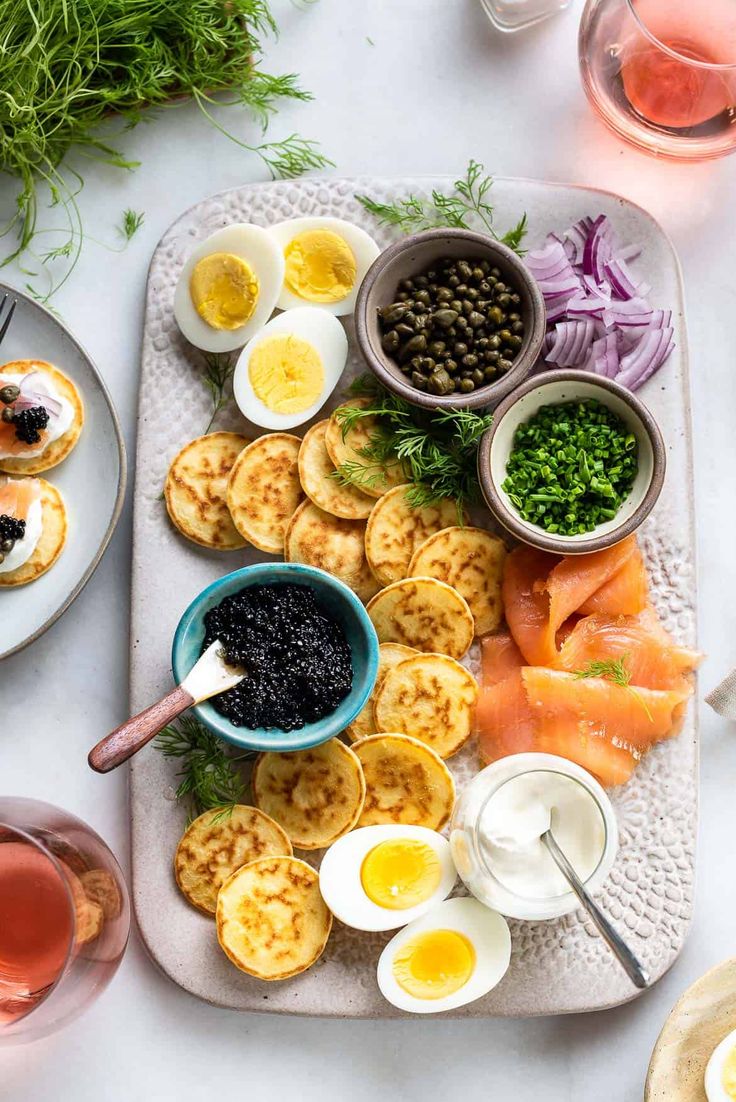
378;258;524;395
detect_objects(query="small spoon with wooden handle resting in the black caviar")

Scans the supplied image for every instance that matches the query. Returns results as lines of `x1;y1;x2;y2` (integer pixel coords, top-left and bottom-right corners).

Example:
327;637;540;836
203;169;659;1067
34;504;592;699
87;639;246;773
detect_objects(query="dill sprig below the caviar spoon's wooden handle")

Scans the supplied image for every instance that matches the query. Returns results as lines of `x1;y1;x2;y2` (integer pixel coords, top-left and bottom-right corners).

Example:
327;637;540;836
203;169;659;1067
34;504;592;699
153;715;253;821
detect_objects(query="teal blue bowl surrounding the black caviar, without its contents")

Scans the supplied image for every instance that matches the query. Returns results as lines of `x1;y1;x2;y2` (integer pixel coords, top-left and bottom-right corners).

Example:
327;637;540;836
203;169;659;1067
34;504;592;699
171;562;378;750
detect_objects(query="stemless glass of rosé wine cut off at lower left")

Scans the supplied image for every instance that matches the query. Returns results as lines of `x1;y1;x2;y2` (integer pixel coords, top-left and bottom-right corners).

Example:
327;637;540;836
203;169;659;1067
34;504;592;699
0;797;130;1047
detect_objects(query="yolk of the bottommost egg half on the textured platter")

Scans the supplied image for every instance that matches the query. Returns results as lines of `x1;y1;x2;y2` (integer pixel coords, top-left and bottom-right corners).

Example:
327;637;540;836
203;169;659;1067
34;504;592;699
393;930;475;998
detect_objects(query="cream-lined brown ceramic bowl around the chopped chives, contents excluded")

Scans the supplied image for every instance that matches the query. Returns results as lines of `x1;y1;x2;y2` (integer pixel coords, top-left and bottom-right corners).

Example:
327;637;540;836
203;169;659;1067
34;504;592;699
478;370;667;554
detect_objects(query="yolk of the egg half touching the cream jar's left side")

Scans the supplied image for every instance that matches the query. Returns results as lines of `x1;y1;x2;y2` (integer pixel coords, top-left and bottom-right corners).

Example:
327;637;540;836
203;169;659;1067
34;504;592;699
360;838;442;910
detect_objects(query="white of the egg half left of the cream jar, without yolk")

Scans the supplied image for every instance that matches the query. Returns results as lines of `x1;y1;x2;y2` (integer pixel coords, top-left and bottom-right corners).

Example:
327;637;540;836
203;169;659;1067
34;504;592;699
320;823;457;930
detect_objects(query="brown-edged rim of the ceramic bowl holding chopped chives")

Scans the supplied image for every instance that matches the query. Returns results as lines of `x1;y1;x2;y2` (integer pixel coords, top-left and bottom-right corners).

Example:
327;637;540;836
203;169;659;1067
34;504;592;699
478;368;667;554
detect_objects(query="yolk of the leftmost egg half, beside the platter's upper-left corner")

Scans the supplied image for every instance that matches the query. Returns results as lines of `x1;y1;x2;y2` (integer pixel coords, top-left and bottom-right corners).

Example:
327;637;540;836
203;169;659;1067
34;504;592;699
190;252;259;329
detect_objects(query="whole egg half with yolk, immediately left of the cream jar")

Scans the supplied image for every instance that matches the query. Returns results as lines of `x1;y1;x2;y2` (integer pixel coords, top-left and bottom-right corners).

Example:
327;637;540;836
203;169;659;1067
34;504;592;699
320;824;457;930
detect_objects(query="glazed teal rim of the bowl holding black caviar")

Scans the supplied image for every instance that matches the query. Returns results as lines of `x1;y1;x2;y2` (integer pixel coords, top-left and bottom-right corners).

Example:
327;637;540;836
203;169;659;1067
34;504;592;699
171;562;379;753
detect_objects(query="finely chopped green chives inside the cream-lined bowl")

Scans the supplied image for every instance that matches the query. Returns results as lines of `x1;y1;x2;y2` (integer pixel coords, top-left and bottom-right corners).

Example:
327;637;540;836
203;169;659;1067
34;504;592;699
502;399;638;536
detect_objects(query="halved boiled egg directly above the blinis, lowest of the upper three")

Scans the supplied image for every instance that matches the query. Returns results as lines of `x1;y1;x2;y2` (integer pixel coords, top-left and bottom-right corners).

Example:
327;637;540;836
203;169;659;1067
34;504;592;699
232;306;347;429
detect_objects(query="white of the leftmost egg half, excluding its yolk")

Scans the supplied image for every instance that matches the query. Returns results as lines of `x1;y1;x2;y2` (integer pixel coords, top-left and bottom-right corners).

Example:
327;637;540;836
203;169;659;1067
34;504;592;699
174;222;284;353
